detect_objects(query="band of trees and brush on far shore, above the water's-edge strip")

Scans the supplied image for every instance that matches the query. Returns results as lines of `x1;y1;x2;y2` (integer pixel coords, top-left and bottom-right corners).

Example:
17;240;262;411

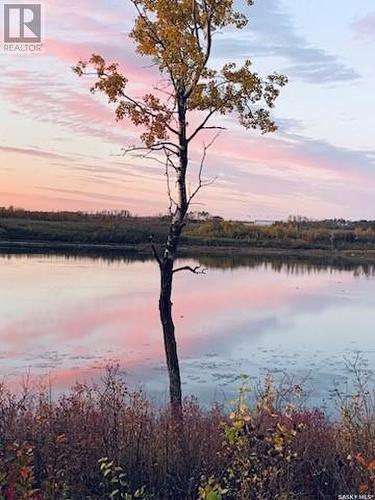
0;207;375;249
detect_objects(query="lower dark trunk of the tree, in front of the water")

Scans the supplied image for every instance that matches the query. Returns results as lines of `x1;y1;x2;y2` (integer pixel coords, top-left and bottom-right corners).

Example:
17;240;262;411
159;259;182;411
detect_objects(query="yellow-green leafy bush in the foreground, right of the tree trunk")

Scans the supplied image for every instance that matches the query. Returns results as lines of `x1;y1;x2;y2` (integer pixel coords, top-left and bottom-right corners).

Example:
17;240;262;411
200;377;303;500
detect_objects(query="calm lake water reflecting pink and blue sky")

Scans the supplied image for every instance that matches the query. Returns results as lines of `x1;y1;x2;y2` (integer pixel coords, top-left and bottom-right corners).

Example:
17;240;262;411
0;255;375;402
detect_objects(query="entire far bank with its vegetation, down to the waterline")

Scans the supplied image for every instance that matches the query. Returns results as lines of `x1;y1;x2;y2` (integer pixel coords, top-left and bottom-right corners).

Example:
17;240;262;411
0;207;375;263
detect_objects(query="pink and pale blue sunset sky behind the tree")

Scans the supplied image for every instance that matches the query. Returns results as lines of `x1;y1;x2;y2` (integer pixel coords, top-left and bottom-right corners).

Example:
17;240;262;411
0;0;375;220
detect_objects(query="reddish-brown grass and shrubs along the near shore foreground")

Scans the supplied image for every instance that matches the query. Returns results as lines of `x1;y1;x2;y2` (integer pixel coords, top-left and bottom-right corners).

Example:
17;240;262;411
0;370;375;500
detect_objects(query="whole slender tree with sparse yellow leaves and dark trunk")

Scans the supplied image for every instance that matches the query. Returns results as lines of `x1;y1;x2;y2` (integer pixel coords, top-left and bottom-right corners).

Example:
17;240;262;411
74;0;287;409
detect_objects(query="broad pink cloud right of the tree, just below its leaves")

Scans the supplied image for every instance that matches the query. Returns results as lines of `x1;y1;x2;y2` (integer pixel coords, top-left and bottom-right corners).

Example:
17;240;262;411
198;132;375;189
